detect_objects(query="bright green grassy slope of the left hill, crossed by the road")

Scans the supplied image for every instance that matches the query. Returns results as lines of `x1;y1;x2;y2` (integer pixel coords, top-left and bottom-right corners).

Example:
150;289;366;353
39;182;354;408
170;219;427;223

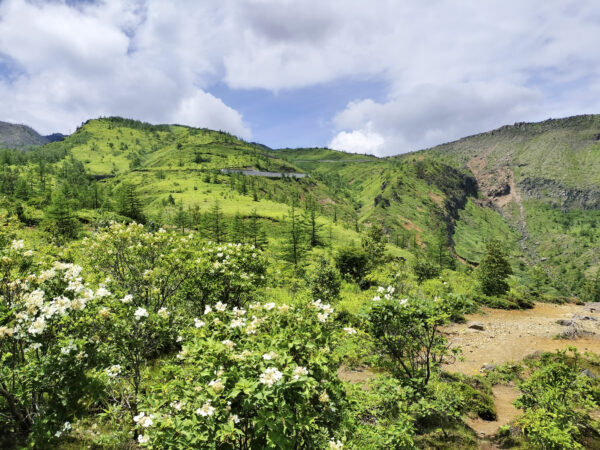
52;119;366;248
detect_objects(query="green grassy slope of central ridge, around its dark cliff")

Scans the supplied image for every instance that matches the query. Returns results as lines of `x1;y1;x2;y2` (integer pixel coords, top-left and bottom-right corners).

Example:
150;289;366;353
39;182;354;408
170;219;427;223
278;149;518;262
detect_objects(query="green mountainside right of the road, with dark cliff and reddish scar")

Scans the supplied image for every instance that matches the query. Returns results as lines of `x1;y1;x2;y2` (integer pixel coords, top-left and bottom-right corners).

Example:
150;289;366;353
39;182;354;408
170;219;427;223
281;115;600;295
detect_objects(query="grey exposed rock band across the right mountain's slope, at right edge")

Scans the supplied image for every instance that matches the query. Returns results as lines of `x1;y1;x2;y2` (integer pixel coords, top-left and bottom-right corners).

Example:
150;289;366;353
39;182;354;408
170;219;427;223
519;178;600;210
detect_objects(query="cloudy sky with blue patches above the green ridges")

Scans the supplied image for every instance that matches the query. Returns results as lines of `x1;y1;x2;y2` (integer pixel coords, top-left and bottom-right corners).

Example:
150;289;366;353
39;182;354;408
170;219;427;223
0;0;600;155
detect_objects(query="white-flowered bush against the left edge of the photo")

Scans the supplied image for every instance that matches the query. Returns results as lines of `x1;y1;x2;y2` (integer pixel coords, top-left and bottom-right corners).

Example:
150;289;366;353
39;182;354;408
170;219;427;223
0;240;99;443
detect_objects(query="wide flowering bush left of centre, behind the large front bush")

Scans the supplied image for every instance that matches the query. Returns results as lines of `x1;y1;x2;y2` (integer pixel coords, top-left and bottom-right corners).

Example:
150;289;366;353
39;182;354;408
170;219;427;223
83;223;266;313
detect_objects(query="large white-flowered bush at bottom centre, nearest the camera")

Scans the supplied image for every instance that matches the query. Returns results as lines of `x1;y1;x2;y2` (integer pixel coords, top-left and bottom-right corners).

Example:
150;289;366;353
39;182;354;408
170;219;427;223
138;301;344;448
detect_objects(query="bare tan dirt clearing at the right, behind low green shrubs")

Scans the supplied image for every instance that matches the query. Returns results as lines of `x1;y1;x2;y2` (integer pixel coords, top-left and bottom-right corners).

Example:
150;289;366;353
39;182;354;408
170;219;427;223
444;303;600;375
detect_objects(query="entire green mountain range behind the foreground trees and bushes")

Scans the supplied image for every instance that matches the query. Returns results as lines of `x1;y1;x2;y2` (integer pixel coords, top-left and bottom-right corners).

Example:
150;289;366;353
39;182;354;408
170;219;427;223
2;116;600;295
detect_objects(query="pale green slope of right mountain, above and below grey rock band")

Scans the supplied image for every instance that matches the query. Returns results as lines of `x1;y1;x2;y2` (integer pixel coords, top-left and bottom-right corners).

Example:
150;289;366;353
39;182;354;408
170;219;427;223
418;115;600;294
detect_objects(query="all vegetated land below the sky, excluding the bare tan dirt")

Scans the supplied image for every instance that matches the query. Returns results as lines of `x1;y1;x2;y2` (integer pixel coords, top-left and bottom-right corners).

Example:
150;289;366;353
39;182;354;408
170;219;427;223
0;116;600;449
